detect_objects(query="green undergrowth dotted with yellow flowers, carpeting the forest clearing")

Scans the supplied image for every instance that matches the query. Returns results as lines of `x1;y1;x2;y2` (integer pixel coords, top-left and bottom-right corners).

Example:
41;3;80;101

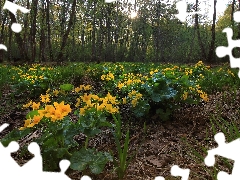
0;61;240;179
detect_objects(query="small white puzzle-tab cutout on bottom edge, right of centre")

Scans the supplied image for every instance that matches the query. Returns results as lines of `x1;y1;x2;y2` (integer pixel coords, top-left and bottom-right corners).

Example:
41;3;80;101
154;165;190;180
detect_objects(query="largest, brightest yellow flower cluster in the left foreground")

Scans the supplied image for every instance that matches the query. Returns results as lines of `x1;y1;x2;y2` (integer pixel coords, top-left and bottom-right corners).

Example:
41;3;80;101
20;101;71;130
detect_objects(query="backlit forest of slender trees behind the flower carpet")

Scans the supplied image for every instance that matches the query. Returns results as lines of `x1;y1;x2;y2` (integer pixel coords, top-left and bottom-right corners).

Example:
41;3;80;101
0;0;240;63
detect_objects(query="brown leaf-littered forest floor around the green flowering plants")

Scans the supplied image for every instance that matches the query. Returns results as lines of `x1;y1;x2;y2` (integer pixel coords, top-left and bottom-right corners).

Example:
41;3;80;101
0;82;240;180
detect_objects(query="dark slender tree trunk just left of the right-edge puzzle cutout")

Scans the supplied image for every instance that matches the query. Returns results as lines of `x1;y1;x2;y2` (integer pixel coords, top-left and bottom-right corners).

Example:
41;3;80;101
207;0;217;62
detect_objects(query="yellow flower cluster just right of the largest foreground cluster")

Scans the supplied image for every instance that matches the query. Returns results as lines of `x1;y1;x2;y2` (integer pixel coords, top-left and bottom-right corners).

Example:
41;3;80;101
75;92;119;115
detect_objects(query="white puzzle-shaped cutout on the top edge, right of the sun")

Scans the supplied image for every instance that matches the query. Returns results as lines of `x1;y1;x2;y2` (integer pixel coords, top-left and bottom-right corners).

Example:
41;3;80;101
175;1;203;22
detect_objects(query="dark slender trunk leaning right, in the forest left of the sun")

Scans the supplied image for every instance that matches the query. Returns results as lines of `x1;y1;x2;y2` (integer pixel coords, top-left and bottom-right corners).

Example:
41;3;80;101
57;0;77;62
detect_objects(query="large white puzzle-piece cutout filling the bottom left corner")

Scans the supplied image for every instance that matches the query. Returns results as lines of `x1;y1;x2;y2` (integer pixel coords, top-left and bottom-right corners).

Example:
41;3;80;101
0;123;94;180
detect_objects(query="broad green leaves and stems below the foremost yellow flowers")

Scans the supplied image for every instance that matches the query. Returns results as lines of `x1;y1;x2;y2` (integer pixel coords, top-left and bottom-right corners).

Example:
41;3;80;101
1;116;112;174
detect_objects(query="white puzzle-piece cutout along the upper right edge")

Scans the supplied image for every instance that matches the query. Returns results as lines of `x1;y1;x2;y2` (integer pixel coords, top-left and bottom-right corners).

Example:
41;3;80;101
216;11;240;78
